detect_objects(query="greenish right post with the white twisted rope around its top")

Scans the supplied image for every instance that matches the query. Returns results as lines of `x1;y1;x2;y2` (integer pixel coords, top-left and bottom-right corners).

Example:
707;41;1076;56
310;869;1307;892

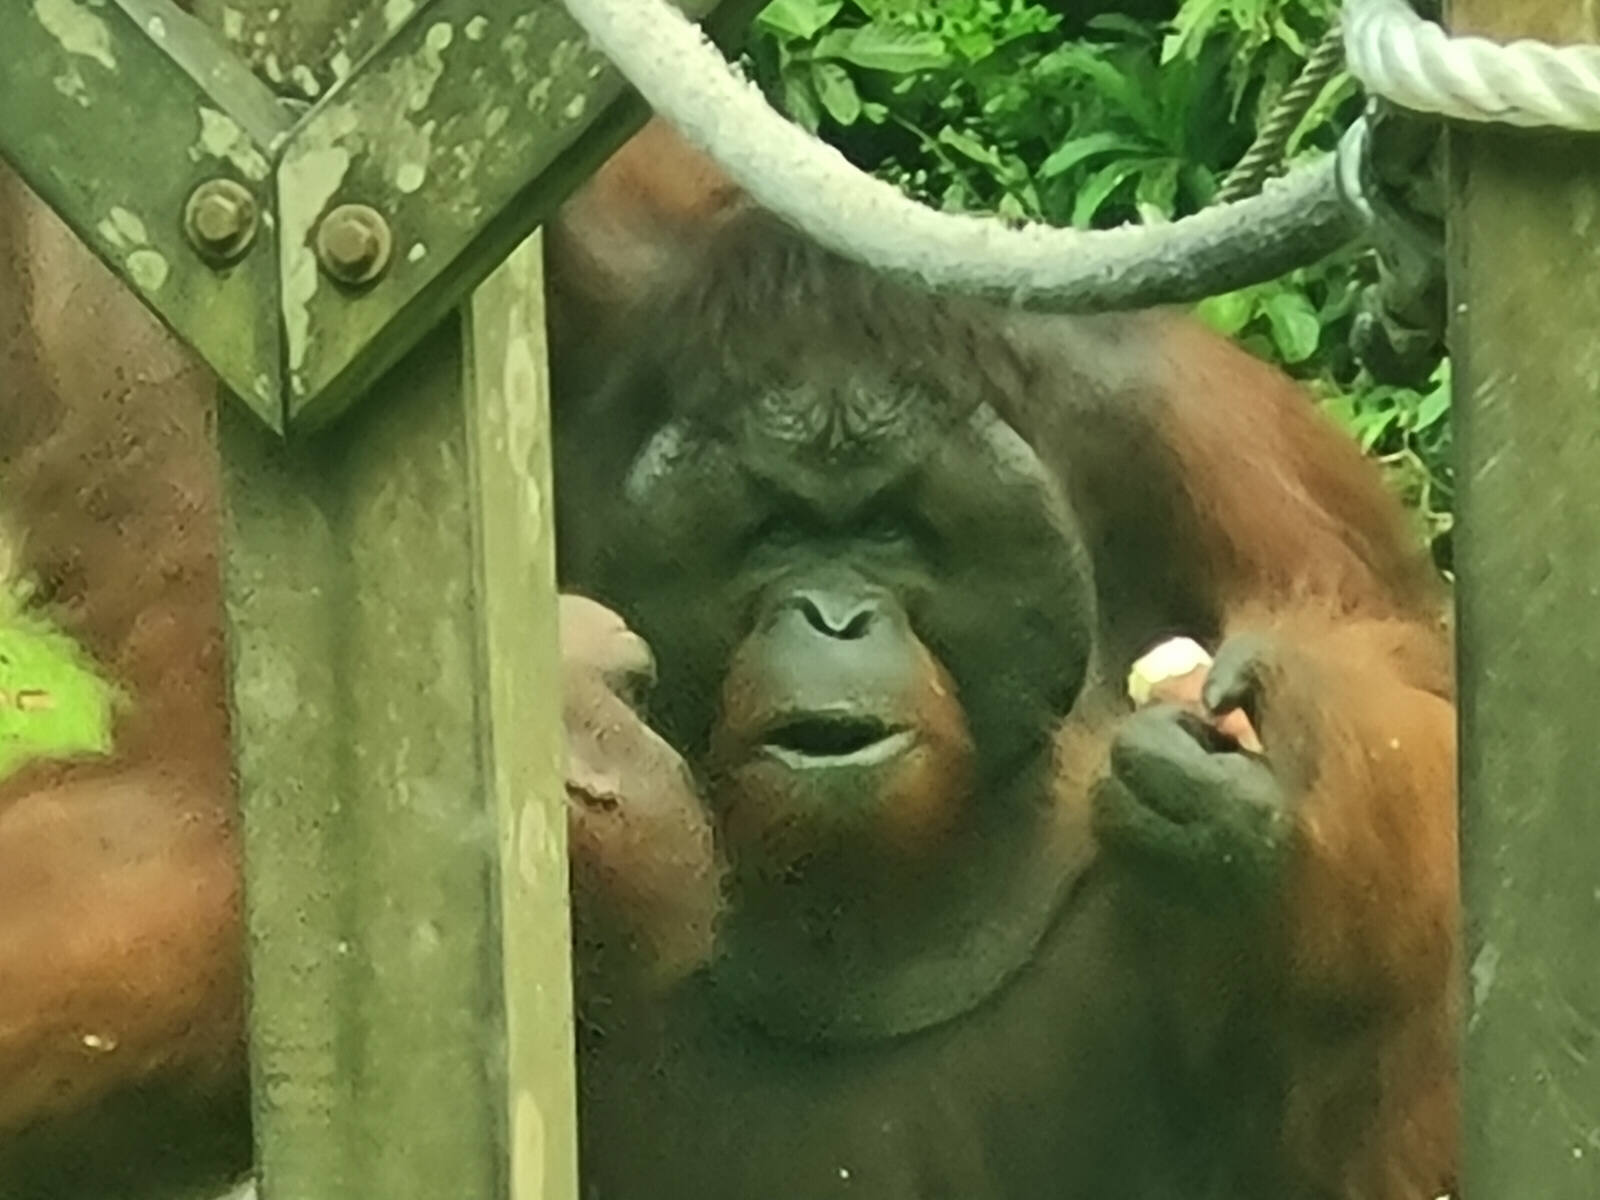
1450;0;1600;1200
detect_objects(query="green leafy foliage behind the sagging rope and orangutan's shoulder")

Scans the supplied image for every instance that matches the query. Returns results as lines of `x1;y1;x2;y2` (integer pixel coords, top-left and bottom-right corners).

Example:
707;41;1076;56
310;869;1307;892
750;0;1451;566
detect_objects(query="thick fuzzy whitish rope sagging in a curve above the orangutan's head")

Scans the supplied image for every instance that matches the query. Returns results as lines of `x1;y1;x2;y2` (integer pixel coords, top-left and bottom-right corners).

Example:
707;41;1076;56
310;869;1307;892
565;0;1354;309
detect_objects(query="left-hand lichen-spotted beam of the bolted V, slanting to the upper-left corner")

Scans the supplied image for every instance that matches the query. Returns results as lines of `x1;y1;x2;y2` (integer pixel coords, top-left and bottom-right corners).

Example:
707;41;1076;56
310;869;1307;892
0;0;290;427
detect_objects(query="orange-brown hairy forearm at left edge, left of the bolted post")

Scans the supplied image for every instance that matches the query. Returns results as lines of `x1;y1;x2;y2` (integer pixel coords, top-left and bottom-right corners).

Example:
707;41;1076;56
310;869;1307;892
0;773;243;1136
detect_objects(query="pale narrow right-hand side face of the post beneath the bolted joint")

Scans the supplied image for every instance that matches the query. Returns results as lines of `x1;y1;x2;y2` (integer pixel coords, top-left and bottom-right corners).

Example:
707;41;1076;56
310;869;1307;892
467;235;578;1200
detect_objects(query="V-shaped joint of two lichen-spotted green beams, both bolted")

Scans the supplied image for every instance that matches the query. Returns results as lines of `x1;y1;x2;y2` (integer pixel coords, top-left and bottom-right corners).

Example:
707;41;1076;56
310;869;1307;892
0;0;739;430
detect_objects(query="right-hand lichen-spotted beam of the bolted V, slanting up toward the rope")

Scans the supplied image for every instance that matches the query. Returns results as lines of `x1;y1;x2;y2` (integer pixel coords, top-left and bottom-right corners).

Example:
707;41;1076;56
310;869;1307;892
277;0;720;424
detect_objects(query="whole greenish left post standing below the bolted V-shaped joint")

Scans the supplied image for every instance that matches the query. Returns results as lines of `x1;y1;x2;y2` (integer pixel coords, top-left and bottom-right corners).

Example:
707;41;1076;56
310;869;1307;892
222;236;576;1200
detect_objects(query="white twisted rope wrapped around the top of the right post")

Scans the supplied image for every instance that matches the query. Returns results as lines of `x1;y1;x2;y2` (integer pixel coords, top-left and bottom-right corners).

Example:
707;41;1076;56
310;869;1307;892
1344;0;1600;133
